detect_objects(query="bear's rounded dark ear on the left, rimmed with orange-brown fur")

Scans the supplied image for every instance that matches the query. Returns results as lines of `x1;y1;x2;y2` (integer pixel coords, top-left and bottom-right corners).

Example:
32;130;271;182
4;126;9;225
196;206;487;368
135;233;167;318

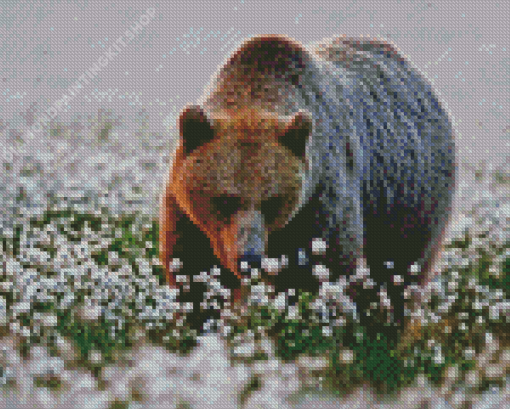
179;105;214;156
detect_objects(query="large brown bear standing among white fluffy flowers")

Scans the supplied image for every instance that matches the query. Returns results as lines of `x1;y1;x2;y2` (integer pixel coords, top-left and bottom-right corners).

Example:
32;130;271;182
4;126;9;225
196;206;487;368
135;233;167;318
160;35;454;330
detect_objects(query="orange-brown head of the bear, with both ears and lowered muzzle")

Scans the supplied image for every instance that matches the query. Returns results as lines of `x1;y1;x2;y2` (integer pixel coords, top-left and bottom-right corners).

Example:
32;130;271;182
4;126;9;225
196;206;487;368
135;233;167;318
171;105;312;278
